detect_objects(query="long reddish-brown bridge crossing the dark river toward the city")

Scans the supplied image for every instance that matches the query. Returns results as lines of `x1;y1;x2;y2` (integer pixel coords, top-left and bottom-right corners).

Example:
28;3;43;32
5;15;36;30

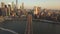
25;14;33;34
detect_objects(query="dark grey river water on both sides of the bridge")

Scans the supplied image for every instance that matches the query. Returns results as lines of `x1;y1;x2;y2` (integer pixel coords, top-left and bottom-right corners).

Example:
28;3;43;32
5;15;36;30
0;18;60;34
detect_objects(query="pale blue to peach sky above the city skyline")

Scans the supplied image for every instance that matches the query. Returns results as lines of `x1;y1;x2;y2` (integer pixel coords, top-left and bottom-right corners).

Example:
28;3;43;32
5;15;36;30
0;0;60;9
